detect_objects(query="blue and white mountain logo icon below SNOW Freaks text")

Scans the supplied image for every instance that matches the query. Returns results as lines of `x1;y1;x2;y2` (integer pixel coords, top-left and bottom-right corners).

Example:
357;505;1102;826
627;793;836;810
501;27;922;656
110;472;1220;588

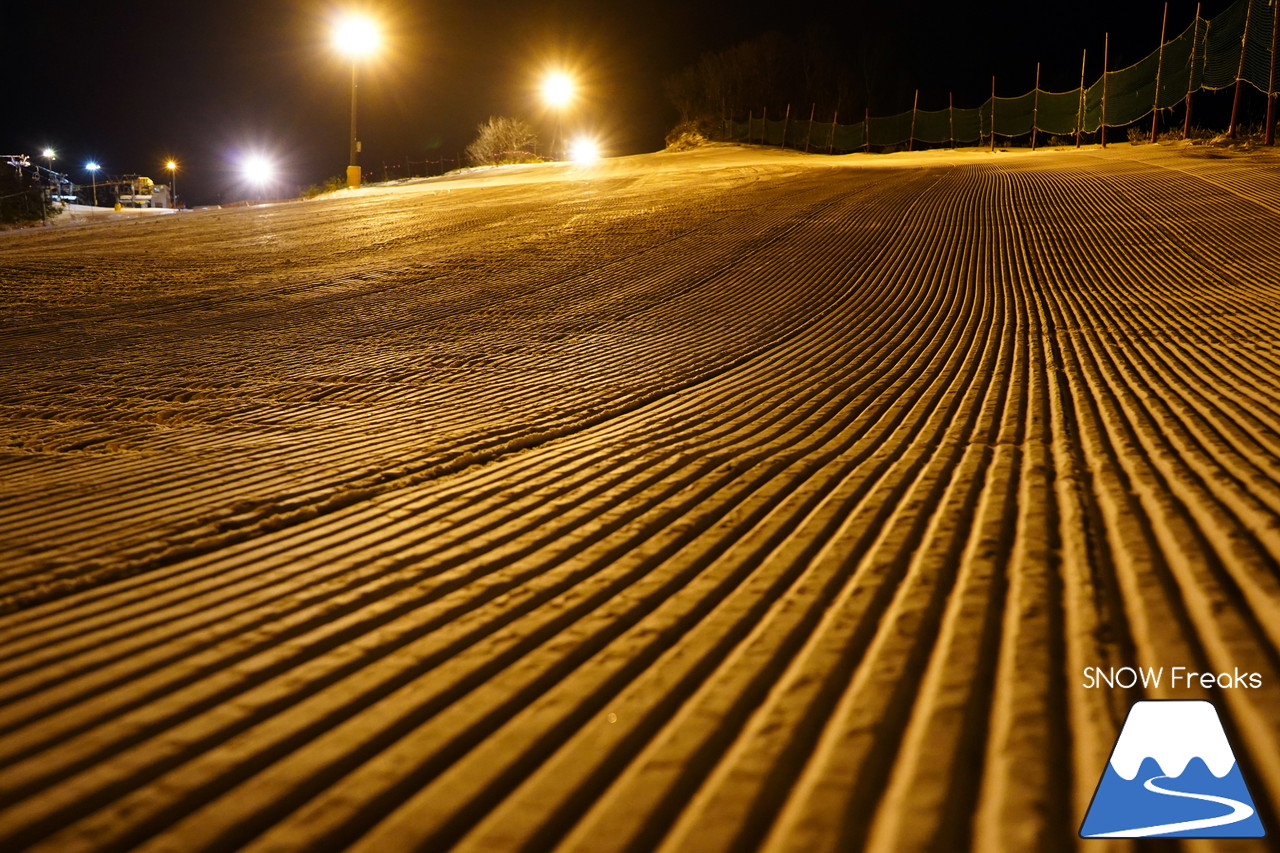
1080;699;1266;838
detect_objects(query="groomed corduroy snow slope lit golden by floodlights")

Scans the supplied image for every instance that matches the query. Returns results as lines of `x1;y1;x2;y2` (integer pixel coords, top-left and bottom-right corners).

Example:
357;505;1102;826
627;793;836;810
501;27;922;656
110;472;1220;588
0;146;1280;853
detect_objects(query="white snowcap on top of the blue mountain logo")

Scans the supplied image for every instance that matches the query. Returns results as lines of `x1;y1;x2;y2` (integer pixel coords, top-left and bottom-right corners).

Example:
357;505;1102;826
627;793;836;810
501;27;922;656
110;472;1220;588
1111;701;1235;780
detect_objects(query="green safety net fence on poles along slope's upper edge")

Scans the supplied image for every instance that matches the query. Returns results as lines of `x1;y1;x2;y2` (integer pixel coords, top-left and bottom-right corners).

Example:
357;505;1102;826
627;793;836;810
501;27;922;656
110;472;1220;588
724;0;1280;152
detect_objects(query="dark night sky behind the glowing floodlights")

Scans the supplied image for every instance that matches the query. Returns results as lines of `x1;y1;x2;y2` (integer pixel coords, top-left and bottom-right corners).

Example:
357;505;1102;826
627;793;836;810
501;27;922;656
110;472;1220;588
0;0;1229;204
